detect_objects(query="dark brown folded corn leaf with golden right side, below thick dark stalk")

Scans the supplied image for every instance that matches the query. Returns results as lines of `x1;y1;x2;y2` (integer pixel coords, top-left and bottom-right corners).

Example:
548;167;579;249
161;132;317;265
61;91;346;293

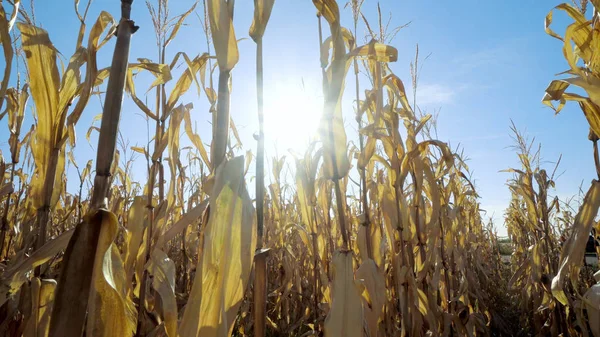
49;209;135;337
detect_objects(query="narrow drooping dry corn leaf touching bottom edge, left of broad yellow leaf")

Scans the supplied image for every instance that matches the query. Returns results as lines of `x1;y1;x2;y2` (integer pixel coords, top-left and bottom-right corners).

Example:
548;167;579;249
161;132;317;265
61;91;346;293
148;249;177;337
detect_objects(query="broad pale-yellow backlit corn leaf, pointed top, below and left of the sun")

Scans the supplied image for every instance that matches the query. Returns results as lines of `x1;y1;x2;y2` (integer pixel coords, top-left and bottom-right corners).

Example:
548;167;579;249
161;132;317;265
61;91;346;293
179;156;256;337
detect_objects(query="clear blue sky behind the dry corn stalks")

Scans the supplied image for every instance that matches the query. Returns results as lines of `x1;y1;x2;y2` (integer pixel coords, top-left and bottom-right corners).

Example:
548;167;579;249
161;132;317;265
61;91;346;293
0;0;594;234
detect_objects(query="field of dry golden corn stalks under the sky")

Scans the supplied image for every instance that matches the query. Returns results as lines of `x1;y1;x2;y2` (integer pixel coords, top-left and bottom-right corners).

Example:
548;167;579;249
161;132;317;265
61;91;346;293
0;0;600;337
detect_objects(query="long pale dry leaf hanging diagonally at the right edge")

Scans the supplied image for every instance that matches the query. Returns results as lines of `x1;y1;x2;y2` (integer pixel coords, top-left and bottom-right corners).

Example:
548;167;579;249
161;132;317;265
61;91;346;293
552;180;600;305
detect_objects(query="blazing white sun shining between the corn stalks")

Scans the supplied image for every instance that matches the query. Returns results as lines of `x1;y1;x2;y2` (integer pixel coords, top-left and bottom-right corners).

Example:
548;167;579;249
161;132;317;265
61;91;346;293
264;80;323;153
